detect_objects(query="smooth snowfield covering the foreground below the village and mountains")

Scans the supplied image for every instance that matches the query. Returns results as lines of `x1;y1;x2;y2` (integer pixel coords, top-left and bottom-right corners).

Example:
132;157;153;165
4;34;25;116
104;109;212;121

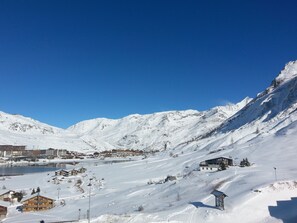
1;123;297;223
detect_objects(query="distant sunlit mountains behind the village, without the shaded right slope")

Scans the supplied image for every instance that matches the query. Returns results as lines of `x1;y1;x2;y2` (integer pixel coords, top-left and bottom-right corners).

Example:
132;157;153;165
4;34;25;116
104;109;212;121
0;98;247;151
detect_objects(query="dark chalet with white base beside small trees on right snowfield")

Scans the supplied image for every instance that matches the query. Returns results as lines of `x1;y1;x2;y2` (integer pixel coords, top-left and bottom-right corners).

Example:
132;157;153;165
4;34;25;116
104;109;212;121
199;157;233;172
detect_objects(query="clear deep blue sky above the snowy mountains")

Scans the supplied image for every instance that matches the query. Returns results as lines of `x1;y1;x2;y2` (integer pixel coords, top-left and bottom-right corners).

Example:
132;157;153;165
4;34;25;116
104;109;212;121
0;0;297;128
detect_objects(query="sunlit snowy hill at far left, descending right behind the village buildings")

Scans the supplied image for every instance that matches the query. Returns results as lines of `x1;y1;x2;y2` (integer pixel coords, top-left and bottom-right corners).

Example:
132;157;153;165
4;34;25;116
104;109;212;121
0;112;92;151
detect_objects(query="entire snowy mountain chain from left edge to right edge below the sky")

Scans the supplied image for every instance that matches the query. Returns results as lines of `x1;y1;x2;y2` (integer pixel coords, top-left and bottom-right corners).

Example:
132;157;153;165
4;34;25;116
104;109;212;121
0;61;297;155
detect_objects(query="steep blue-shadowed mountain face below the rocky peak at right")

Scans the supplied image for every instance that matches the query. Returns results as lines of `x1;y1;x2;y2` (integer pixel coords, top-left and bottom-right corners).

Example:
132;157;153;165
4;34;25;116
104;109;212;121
222;62;297;131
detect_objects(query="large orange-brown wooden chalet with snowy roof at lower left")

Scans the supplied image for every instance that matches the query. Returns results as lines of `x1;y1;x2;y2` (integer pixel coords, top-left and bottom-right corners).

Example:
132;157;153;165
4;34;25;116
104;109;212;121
22;194;54;212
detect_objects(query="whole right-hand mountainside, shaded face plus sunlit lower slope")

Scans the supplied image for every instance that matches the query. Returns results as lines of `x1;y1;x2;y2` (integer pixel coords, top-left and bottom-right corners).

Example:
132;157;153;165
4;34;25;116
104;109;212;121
177;61;297;150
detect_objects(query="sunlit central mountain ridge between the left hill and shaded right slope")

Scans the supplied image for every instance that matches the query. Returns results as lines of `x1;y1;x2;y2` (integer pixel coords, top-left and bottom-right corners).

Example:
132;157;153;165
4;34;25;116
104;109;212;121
68;98;251;150
